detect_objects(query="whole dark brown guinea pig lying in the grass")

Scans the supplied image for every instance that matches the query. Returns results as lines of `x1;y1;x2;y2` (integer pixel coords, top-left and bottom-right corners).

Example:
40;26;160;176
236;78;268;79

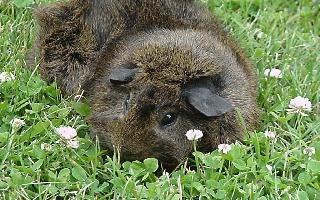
35;0;259;167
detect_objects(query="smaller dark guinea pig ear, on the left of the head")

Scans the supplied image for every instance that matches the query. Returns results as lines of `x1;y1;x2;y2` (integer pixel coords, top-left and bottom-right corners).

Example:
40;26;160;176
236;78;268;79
109;65;138;85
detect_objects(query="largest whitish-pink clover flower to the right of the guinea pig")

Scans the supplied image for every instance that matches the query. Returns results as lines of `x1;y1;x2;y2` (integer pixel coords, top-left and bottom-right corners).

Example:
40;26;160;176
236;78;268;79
287;96;312;116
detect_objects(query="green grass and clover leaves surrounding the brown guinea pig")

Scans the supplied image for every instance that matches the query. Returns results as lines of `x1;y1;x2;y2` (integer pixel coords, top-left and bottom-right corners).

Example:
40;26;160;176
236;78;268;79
0;0;320;200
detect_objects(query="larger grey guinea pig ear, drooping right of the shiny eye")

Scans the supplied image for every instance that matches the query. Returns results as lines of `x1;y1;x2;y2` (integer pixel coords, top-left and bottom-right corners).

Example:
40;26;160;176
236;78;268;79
184;86;233;117
